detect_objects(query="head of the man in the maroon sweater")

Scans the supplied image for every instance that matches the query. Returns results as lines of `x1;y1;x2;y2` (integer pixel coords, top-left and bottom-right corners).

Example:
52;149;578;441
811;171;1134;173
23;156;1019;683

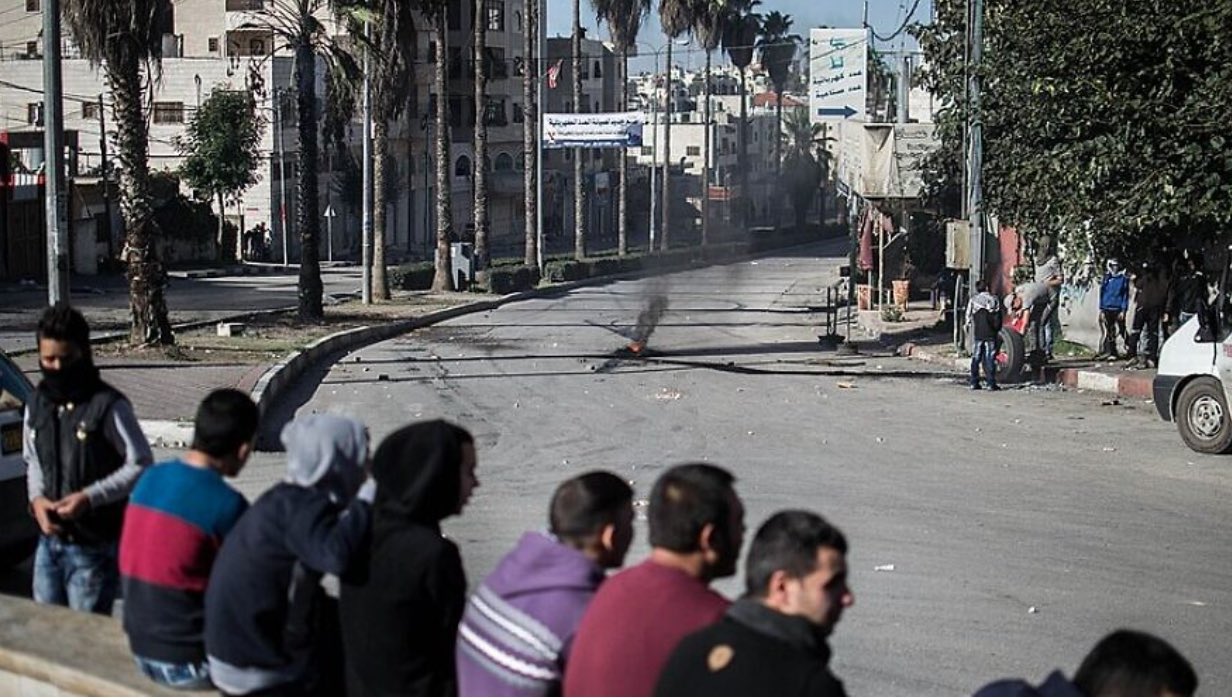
648;463;744;581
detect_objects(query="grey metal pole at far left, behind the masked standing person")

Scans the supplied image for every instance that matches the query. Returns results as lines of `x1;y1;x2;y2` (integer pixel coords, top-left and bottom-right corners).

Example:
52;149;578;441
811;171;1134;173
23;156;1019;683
43;0;69;305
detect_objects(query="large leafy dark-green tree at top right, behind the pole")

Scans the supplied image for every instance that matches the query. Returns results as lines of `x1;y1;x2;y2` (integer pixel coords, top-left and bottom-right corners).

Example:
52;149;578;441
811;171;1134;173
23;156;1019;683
914;0;1232;263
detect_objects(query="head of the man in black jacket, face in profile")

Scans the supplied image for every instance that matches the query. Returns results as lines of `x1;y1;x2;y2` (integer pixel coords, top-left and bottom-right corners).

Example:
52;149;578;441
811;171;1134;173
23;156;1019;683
744;511;855;635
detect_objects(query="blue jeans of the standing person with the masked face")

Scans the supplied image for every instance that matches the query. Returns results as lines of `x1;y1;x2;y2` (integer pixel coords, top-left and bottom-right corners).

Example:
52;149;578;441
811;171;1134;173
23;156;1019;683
33;536;120;616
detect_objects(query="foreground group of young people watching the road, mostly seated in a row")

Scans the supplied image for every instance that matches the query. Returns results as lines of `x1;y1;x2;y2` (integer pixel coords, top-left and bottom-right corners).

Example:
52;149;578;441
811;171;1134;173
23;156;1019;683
25;305;1198;696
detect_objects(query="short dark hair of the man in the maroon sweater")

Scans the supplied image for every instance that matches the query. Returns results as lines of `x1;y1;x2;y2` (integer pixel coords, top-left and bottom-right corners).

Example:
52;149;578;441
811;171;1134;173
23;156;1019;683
648;463;736;553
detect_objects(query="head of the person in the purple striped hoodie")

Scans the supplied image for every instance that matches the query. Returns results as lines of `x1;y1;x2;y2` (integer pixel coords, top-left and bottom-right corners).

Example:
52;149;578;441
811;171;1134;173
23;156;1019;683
548;470;633;569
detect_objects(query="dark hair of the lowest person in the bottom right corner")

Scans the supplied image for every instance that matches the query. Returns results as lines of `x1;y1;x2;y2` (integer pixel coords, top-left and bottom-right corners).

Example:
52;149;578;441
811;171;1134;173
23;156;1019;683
1074;630;1198;696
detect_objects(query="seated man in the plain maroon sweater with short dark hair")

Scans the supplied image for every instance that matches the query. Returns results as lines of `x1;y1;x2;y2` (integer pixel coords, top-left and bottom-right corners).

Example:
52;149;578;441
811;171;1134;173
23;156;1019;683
564;463;744;696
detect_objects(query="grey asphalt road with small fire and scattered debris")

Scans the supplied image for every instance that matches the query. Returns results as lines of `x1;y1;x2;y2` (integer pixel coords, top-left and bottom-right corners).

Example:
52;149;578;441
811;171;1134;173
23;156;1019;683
267;242;1232;694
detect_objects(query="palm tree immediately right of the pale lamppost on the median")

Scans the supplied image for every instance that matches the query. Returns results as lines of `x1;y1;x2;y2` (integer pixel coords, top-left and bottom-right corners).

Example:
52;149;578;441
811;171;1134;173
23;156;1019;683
372;0;415;300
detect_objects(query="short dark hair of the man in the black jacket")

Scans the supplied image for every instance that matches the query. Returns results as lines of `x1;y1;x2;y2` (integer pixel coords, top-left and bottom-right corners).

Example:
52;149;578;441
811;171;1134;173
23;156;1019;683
744;510;846;598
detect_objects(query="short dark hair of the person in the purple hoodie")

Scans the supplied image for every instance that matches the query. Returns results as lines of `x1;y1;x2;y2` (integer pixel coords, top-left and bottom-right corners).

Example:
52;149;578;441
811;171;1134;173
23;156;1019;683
548;470;633;543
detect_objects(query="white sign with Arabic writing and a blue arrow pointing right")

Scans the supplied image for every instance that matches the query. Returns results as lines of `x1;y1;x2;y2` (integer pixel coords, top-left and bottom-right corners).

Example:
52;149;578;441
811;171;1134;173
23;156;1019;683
808;28;869;122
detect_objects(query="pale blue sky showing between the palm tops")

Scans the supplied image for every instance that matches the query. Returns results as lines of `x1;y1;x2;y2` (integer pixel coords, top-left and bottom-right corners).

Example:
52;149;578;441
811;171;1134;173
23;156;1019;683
547;0;933;74
